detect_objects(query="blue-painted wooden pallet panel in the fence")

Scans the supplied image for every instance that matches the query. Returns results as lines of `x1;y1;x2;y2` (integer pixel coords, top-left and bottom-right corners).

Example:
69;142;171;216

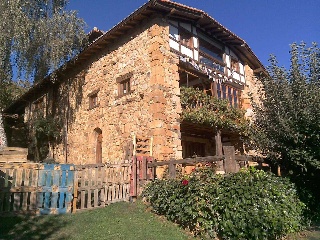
37;164;74;215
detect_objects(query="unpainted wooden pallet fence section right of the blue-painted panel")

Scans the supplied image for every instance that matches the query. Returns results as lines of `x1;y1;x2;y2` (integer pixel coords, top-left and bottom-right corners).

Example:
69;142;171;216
73;161;131;212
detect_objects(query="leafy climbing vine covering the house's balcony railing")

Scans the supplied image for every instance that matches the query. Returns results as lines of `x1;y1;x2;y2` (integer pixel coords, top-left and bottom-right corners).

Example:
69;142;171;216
181;87;249;136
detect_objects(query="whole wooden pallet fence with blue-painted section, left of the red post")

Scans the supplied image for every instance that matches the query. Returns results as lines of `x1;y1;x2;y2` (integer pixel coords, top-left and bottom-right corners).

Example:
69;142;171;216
0;161;131;215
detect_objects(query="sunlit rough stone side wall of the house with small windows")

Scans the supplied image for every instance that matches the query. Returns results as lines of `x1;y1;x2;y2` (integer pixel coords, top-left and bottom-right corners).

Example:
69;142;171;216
22;18;182;164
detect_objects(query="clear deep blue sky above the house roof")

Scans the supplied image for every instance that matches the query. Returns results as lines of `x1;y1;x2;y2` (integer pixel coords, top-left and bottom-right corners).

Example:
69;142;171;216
68;0;320;67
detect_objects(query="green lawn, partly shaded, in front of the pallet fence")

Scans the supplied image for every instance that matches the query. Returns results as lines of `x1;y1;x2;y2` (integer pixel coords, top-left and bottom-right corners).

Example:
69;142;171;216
0;202;194;240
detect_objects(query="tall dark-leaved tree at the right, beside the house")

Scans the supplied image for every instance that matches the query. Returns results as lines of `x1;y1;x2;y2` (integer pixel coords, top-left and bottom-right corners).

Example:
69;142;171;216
253;43;320;208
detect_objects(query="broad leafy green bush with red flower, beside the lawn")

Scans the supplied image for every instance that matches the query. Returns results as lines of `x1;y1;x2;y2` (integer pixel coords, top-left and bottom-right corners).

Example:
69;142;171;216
143;168;305;239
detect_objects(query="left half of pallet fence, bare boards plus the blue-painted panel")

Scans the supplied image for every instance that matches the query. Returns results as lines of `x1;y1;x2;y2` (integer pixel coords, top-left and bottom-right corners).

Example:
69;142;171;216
0;163;74;215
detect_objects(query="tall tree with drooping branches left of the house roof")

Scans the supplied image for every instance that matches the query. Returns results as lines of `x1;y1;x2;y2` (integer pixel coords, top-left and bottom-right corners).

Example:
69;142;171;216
0;0;85;109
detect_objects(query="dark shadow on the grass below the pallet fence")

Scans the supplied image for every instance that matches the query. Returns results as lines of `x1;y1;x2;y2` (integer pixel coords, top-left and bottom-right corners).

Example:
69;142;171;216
0;215;68;240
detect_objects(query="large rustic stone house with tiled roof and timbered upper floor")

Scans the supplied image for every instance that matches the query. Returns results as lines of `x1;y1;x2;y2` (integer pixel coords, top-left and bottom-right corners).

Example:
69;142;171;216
6;0;265;164
